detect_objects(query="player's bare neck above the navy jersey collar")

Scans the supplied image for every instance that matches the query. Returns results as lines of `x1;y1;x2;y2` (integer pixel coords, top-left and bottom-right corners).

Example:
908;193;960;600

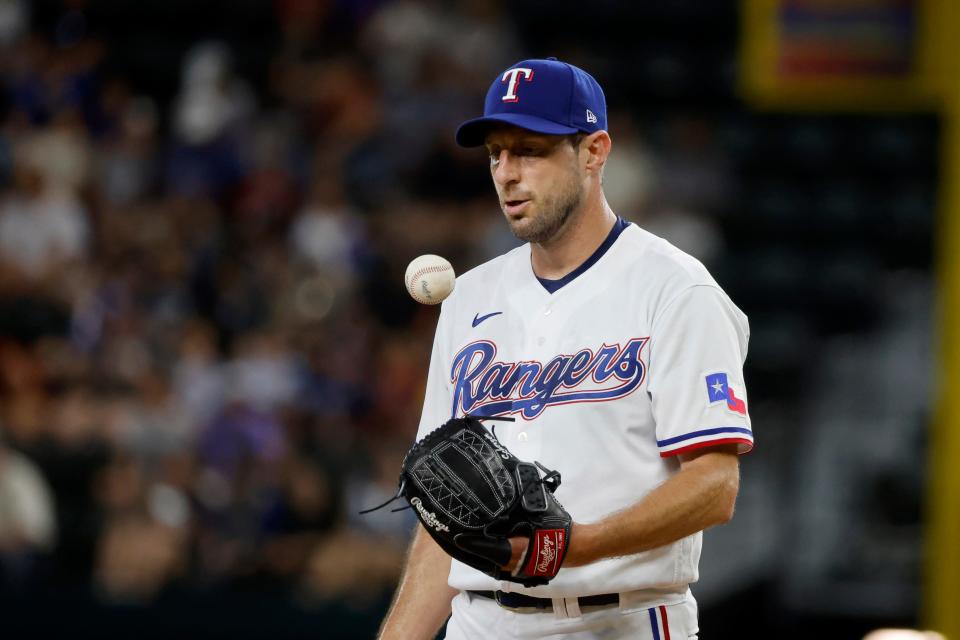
530;195;617;280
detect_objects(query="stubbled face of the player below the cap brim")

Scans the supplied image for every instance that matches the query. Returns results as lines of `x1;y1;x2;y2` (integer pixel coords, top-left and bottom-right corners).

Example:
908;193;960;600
485;126;584;243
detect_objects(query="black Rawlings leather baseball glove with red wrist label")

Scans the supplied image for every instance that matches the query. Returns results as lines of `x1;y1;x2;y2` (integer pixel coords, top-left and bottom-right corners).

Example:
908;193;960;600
370;416;572;587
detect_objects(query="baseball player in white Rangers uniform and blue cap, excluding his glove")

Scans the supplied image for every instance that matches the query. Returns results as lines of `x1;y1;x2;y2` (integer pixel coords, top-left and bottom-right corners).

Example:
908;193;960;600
381;58;753;640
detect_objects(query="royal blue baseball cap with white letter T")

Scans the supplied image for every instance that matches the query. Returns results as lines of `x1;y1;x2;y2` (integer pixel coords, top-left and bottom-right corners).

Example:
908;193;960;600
457;58;607;147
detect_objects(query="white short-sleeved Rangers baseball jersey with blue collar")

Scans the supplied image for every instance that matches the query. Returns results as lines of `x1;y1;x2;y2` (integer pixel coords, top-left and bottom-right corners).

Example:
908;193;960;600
417;219;753;599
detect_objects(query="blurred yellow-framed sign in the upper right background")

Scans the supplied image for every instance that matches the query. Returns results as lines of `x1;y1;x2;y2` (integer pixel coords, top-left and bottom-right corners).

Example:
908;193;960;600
740;0;950;111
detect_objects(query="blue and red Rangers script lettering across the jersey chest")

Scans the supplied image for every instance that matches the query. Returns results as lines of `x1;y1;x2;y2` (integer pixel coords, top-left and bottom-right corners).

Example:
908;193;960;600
450;338;649;420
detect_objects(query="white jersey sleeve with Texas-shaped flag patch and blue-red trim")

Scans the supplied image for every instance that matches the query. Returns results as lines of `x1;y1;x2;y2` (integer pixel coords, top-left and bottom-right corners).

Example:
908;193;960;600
647;285;753;458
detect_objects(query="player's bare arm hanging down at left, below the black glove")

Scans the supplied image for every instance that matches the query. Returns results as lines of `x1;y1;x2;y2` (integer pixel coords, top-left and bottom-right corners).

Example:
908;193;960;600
378;525;457;640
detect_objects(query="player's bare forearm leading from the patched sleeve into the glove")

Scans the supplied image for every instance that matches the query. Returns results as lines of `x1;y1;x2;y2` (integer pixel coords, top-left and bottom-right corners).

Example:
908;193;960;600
563;451;739;567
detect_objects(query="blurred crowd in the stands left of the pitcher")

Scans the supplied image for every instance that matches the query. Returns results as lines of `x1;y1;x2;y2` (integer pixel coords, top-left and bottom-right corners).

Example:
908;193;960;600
0;2;499;602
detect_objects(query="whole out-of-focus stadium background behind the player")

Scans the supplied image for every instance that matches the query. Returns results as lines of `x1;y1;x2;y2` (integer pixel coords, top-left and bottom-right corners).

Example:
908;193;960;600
0;0;960;639
